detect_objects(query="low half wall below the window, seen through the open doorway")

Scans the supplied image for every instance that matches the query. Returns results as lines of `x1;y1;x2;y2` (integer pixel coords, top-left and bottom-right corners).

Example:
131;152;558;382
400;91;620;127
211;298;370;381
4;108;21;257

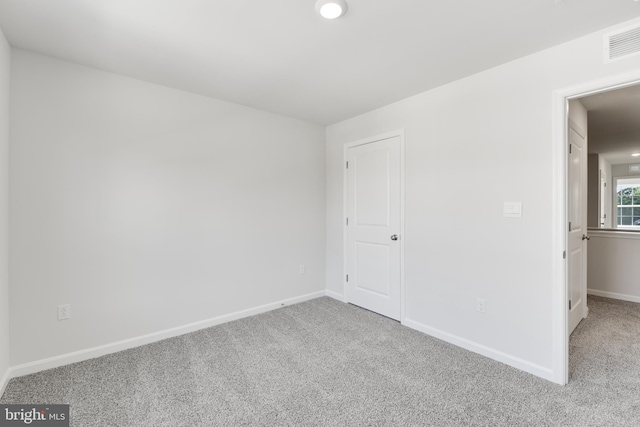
587;230;640;302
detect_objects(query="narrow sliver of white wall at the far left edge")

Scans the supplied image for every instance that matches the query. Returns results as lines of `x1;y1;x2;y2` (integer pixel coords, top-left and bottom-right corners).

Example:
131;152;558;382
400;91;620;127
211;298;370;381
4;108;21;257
0;30;11;396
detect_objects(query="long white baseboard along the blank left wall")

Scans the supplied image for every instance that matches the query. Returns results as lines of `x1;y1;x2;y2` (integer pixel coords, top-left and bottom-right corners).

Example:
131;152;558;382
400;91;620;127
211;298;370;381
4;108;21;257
3;291;325;382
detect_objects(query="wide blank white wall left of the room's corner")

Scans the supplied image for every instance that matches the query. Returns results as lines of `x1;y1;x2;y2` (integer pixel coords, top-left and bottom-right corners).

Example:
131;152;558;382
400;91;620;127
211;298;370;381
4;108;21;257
10;50;325;366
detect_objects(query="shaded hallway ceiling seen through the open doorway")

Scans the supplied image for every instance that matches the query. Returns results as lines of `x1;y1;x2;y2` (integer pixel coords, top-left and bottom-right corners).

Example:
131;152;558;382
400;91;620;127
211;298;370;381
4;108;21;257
580;85;640;165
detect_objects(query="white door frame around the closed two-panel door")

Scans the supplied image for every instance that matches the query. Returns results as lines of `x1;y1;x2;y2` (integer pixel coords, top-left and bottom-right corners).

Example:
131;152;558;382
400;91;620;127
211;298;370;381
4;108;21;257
342;129;406;323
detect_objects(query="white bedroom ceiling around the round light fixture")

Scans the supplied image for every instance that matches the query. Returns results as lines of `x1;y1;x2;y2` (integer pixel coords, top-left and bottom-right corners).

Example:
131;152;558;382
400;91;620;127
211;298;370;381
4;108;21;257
0;0;640;124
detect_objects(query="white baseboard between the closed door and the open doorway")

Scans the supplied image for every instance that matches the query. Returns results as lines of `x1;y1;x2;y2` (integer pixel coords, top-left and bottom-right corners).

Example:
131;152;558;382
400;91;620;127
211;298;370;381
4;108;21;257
402;319;554;381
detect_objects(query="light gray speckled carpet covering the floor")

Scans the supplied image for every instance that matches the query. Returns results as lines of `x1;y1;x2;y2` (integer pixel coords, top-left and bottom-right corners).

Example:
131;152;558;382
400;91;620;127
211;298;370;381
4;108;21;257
0;297;640;427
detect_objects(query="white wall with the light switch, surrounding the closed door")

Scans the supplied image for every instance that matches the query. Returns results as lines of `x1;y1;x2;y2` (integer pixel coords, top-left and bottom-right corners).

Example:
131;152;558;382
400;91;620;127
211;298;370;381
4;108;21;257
327;18;640;380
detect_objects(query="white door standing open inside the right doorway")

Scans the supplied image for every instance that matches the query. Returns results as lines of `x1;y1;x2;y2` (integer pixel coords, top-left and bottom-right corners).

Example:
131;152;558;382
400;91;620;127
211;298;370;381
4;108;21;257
567;122;588;334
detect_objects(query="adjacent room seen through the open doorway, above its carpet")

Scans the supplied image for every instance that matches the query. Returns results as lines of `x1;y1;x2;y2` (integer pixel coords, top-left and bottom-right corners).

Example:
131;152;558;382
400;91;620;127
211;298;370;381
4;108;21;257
580;85;640;303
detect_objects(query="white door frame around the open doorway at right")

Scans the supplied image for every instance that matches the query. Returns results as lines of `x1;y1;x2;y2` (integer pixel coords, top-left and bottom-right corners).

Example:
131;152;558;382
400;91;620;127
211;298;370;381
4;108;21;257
551;71;640;384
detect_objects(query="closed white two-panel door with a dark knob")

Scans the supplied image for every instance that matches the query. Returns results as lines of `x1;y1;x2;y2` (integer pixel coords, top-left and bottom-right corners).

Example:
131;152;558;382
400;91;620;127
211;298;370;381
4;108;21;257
346;136;402;320
